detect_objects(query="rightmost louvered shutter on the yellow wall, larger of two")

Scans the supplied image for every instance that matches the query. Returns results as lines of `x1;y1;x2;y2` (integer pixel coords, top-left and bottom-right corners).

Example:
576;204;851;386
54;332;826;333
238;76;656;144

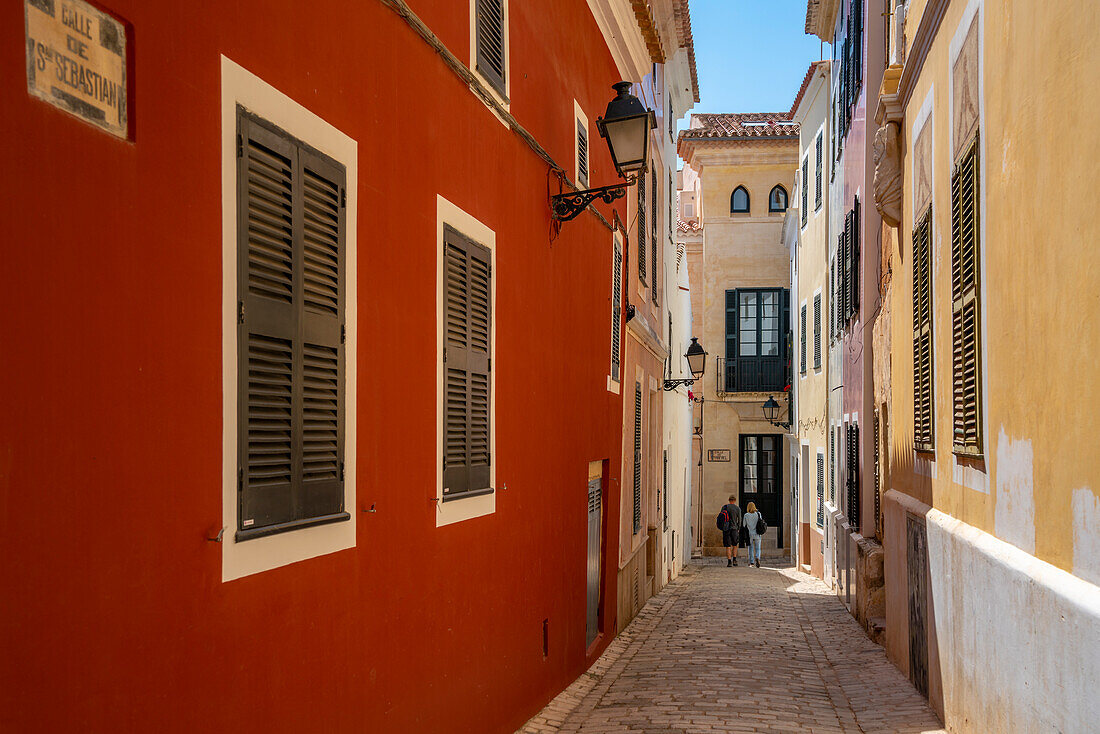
952;134;982;454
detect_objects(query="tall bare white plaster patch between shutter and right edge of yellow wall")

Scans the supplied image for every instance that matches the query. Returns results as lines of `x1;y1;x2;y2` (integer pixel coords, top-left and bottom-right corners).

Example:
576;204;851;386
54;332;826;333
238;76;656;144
993;427;1035;554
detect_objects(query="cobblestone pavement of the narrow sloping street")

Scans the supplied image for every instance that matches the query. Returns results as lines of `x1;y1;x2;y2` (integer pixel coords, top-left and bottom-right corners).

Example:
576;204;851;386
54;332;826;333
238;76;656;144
519;559;944;734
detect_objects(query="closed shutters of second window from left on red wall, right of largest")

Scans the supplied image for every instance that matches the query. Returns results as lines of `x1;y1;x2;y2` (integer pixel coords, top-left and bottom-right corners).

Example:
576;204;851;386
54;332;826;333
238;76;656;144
443;227;493;502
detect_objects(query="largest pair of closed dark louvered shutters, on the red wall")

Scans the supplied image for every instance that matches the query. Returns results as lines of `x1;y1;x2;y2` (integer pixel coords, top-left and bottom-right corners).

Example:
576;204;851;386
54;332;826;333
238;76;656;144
235;107;350;541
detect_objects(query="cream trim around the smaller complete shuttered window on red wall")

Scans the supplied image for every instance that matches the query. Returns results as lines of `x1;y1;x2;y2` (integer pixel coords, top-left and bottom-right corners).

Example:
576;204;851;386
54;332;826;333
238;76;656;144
435;195;499;527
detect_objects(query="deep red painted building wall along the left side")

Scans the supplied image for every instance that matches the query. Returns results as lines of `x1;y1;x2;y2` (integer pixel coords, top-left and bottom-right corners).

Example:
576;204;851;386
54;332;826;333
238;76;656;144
0;0;625;734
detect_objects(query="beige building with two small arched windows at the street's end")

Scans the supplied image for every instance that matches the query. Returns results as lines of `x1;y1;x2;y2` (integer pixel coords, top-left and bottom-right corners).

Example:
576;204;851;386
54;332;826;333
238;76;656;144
679;113;799;555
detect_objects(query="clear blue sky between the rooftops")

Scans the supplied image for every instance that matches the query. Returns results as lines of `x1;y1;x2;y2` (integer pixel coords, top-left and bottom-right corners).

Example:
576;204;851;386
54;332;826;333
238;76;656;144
680;0;832;129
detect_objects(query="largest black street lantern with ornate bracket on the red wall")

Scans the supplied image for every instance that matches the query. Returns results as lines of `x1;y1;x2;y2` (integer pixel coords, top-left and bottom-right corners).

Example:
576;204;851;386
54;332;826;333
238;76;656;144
550;81;657;221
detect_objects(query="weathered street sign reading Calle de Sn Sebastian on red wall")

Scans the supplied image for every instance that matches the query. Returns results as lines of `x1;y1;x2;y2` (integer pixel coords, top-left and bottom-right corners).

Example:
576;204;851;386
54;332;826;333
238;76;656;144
23;0;128;138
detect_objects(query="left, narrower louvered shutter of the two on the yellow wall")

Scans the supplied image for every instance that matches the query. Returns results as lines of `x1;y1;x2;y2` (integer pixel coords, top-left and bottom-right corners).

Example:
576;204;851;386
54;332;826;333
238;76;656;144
913;207;935;451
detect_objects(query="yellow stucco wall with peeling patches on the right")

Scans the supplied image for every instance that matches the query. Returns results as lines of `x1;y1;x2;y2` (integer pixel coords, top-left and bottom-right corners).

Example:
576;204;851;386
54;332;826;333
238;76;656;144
890;0;1100;578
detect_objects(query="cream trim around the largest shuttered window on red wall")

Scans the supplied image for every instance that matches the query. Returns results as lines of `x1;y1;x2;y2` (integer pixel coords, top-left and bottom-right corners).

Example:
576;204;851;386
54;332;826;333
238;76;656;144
221;56;359;582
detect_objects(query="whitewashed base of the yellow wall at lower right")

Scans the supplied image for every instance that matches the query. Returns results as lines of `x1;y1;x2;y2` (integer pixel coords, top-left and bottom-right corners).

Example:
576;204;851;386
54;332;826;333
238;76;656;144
927;510;1100;733
